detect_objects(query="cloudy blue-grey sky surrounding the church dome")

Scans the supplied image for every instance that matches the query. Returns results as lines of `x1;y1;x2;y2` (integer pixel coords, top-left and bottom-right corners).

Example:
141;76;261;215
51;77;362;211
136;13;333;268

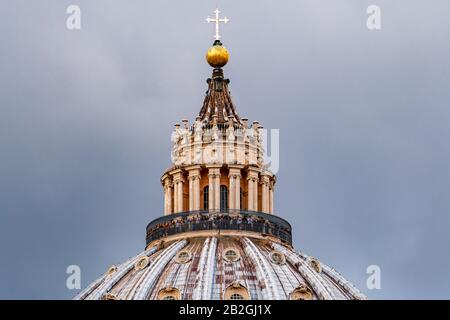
0;0;450;299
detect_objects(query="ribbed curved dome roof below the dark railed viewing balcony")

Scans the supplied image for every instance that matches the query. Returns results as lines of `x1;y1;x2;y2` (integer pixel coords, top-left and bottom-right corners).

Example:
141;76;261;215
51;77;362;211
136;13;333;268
76;234;365;300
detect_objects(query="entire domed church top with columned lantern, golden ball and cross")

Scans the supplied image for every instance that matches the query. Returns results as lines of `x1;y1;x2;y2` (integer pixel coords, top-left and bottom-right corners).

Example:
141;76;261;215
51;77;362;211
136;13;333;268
76;9;365;300
